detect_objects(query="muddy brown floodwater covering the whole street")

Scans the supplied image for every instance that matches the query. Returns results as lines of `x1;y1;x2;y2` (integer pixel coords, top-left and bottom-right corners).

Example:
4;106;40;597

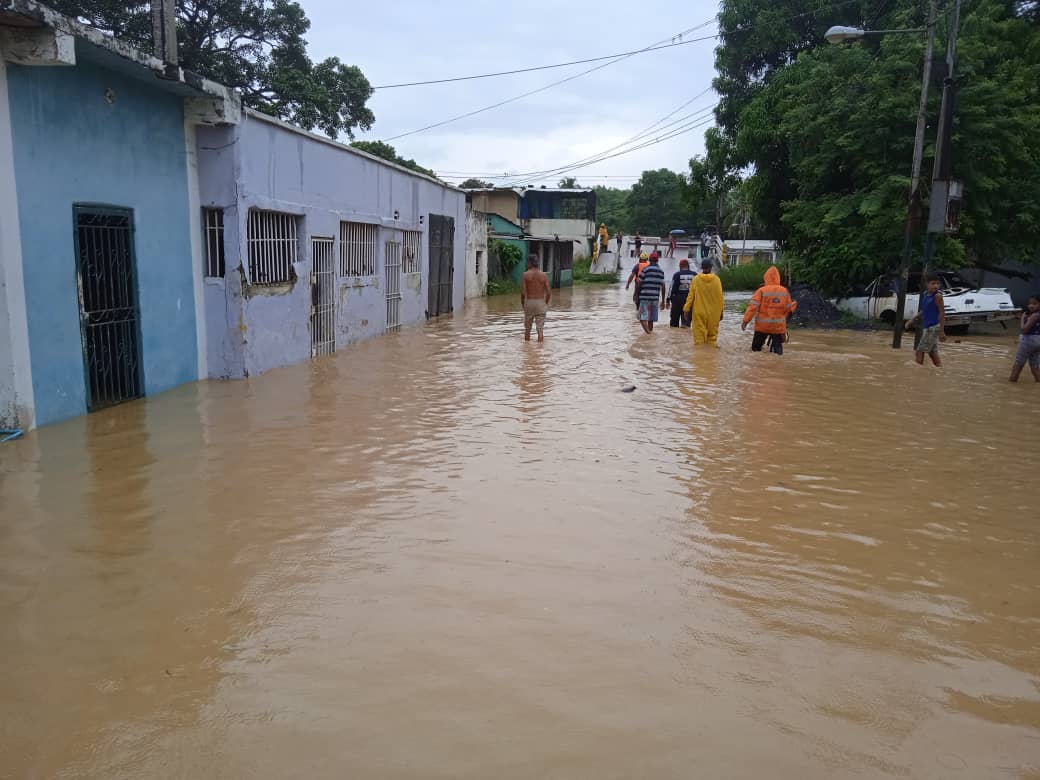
0;278;1040;780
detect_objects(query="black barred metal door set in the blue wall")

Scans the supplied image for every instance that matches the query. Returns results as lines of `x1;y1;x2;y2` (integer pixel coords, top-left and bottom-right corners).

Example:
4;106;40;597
73;206;144;412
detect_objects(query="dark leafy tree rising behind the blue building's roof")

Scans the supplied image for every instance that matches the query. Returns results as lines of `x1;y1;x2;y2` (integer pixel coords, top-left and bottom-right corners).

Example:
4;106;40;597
49;0;375;138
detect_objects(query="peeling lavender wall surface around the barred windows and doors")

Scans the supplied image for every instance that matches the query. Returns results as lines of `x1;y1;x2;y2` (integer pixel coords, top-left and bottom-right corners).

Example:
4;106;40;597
199;113;466;378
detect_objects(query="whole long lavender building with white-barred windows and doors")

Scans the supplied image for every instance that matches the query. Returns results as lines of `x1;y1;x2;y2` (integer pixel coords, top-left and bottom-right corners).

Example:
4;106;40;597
198;111;466;378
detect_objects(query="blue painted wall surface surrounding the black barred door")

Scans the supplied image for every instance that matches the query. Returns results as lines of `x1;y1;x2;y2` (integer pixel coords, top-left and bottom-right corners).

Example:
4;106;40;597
7;58;198;425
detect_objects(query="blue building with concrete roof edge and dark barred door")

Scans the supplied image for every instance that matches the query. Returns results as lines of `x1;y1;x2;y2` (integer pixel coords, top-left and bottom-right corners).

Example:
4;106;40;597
0;0;240;428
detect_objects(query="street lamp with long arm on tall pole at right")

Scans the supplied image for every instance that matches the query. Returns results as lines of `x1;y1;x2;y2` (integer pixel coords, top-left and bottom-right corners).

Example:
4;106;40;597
824;5;960;349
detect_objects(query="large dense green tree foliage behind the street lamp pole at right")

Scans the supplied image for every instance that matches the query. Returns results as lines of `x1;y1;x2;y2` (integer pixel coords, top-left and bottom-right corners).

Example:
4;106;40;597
717;0;1040;292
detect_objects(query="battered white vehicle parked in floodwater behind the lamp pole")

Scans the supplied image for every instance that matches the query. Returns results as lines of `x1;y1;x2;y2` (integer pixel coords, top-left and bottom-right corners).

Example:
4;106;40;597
832;270;1021;328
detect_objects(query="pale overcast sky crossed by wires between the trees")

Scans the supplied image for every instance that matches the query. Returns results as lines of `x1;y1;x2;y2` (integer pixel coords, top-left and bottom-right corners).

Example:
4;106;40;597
301;0;718;186
